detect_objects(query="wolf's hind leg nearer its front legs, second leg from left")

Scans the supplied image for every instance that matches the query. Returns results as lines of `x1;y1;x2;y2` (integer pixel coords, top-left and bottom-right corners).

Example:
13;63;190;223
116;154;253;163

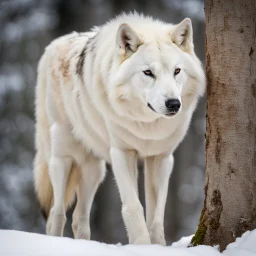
72;156;106;240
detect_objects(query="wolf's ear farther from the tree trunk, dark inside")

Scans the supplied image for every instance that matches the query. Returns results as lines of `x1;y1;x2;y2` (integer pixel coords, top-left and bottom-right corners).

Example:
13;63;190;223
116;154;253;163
116;24;142;56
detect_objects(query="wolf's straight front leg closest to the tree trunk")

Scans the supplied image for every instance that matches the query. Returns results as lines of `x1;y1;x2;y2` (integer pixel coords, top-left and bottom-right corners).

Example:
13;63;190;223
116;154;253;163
145;155;174;245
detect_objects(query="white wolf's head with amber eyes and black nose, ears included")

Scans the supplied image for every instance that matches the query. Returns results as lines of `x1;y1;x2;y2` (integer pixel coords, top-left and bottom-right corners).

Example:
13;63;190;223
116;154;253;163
108;18;205;121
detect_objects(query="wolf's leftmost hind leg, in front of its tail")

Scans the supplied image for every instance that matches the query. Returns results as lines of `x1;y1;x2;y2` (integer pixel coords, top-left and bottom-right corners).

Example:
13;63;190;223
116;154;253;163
46;122;75;236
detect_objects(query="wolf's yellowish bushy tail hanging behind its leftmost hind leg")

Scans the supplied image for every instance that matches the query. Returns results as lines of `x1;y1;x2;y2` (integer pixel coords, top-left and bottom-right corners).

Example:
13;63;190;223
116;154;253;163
34;152;79;220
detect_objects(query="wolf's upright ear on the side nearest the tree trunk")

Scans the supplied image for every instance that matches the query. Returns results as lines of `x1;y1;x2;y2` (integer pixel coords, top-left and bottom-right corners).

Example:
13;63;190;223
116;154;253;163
171;18;194;53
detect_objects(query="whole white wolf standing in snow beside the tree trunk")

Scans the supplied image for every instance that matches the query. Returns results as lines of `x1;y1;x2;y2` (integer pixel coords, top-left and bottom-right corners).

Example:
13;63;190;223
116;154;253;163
34;13;205;245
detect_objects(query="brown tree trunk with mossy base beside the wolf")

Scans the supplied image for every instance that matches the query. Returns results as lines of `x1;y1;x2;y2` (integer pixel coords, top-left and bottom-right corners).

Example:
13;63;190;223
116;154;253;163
191;0;256;251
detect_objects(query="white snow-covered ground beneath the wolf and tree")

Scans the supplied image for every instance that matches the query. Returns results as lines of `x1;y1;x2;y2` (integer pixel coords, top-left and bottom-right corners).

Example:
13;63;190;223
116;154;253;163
0;230;256;256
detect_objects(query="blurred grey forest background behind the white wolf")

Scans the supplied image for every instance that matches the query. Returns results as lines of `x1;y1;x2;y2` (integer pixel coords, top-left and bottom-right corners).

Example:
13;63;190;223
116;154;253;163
0;0;205;244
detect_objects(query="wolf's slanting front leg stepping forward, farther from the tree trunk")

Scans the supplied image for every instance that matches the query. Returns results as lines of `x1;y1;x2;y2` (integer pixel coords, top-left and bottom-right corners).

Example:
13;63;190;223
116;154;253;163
110;148;150;244
